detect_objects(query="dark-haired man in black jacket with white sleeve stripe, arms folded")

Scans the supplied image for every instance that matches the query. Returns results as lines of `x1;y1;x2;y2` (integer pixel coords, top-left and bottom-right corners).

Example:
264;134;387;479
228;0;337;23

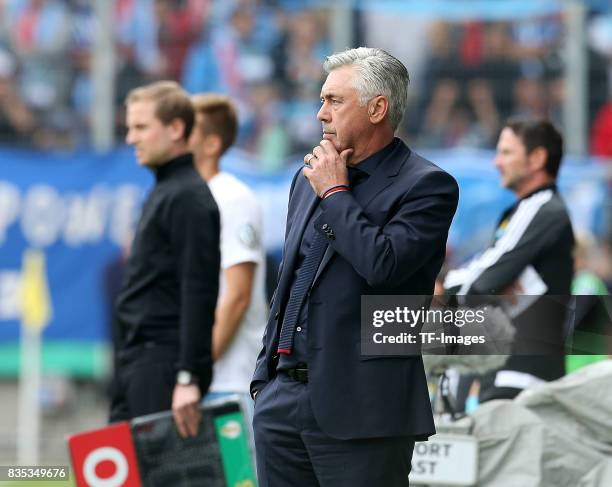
444;120;574;401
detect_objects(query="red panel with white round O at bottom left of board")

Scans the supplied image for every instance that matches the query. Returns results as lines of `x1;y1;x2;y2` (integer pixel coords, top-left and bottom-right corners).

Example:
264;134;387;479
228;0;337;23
68;421;141;487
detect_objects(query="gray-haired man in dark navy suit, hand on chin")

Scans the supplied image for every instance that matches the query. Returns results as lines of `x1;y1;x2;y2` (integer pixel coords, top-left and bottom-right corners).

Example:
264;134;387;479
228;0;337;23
251;47;458;487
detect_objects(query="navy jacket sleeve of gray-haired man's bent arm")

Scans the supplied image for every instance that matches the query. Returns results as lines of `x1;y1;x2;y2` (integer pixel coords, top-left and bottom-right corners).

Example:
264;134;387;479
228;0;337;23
315;170;459;287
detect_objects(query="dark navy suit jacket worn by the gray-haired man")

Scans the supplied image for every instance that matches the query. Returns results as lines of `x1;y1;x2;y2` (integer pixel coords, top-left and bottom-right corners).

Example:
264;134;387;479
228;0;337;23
251;142;459;439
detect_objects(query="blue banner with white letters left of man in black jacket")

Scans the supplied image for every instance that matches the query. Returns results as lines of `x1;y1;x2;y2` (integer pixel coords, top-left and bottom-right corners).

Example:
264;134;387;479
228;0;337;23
0;150;152;340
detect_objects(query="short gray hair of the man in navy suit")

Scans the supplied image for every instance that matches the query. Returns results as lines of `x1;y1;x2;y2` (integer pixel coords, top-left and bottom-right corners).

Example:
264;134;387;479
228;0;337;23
323;47;410;130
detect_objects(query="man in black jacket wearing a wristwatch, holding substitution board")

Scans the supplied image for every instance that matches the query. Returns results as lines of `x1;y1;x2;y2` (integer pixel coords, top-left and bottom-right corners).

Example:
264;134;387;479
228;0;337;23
110;82;220;437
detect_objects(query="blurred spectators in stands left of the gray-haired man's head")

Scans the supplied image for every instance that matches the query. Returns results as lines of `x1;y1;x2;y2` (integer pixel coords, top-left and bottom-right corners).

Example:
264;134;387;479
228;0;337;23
0;0;330;169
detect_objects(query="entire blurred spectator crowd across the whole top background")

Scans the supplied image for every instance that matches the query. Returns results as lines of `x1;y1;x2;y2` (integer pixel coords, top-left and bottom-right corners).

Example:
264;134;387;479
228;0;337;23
0;0;612;163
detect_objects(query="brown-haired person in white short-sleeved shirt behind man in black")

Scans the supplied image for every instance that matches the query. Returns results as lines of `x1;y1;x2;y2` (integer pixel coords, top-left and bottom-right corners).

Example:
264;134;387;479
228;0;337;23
190;94;267;422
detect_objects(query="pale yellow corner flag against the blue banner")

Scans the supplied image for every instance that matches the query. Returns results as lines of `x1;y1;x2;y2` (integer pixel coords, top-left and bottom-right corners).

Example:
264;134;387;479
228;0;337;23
21;249;53;331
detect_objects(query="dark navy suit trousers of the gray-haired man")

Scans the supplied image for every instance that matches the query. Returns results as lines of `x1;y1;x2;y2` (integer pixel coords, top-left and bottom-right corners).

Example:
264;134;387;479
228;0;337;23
253;373;414;487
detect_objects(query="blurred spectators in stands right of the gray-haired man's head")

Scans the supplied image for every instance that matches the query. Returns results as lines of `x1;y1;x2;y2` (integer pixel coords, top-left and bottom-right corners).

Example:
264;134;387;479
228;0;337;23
407;14;612;156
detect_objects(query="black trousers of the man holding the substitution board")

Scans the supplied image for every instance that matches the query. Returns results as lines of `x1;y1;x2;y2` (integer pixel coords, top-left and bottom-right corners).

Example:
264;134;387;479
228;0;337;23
109;342;178;423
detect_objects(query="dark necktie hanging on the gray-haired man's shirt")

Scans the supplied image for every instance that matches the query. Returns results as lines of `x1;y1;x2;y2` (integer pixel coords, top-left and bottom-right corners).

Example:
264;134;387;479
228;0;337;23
278;225;327;355
